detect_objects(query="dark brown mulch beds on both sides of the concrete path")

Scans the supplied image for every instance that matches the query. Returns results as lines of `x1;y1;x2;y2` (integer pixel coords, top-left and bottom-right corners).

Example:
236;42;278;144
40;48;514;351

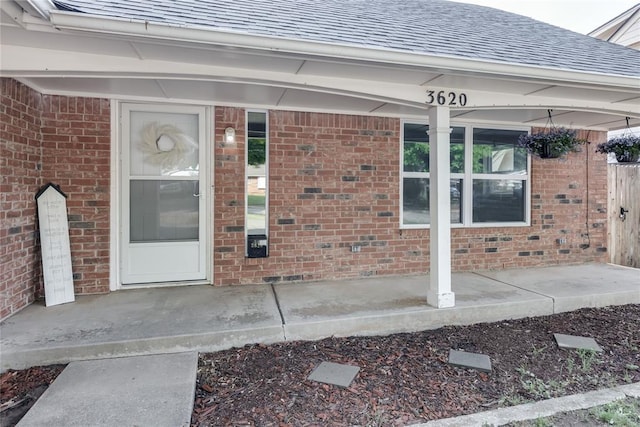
0;305;640;426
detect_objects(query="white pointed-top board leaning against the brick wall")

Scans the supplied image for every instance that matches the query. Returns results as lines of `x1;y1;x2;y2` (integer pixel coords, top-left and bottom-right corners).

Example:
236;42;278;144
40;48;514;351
36;184;75;307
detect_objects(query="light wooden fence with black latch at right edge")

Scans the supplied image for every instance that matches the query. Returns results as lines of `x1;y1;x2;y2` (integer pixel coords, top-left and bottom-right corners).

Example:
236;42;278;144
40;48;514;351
608;163;640;268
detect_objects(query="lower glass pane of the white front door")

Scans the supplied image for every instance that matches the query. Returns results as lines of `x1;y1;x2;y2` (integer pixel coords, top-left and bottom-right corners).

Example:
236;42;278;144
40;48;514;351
130;180;199;242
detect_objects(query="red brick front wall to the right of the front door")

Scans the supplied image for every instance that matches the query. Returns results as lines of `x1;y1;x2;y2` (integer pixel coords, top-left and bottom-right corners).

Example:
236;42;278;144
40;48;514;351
214;108;607;285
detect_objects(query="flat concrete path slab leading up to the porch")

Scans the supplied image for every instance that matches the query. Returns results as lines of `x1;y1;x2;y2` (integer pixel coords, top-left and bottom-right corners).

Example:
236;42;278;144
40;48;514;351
18;352;198;427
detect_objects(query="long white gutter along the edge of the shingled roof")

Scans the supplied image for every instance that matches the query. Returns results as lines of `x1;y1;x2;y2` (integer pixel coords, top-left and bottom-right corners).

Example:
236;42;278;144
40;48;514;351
50;11;638;90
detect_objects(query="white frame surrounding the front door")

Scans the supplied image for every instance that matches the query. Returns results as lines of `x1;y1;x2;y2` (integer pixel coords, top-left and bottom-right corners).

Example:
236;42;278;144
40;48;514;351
109;99;214;291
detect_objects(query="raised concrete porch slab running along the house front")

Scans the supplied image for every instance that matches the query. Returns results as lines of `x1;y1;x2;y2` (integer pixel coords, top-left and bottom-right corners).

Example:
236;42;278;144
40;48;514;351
0;264;640;371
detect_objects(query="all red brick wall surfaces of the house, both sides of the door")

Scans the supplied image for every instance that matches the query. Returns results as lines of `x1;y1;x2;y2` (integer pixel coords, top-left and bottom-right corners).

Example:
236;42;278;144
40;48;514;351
0;85;607;318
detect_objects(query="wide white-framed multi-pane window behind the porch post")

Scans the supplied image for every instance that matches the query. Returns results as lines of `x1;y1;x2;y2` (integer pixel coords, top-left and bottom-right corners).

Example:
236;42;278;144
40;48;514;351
400;121;530;228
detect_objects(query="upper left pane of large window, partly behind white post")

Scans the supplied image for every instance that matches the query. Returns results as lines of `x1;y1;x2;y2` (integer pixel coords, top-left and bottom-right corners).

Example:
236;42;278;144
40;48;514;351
404;123;464;173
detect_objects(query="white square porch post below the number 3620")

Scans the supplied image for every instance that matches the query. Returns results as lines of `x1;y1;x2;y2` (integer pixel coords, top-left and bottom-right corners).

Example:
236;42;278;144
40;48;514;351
427;106;455;308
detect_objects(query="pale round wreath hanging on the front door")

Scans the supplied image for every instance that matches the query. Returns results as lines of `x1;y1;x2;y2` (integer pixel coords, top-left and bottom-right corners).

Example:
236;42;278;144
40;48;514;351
139;122;195;169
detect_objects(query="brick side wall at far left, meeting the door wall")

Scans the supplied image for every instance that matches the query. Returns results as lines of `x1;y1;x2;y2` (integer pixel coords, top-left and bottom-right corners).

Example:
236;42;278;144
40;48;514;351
0;78;42;319
